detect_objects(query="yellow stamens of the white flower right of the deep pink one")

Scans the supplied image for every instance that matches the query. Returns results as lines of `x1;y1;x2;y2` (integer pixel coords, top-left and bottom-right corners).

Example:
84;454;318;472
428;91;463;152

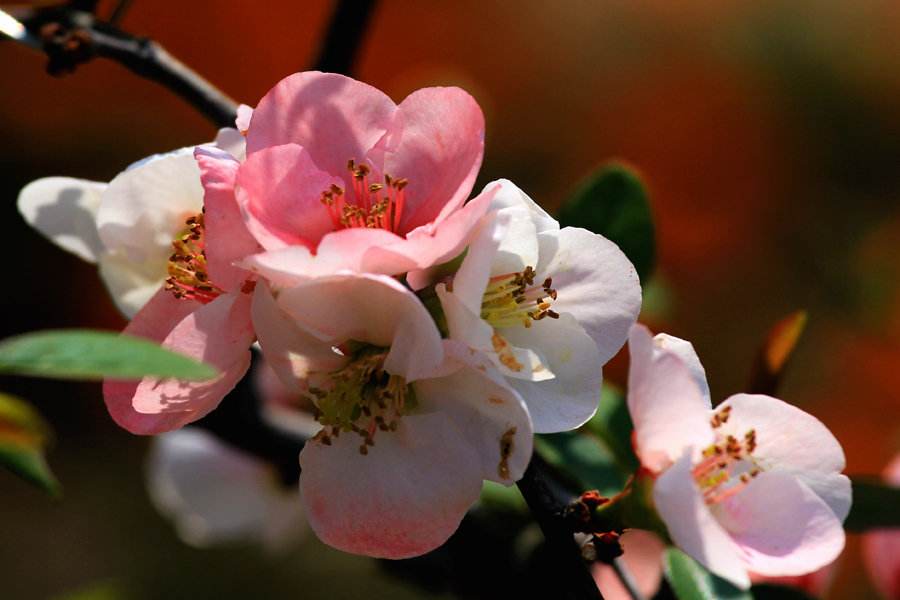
481;267;559;328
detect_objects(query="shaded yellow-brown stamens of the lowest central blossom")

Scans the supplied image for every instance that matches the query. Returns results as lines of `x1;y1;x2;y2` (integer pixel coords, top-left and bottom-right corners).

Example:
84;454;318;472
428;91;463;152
308;346;418;454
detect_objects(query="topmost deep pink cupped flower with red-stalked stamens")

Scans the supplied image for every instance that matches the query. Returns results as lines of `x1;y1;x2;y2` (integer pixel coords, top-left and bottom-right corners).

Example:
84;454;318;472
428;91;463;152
199;72;493;285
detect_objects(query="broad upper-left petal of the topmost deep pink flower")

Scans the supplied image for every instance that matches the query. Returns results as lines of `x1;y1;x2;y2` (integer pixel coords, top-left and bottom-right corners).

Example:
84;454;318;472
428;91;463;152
247;71;397;176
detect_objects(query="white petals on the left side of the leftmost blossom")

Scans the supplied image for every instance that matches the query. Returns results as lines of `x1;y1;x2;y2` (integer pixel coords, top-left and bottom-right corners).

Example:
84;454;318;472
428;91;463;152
18;129;244;318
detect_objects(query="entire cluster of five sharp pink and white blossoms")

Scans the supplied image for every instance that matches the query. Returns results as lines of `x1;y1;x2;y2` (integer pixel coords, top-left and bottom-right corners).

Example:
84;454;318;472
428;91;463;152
19;72;849;585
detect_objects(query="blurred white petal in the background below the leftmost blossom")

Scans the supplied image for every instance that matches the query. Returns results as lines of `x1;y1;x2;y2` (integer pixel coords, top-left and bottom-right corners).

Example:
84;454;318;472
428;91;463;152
147;428;305;547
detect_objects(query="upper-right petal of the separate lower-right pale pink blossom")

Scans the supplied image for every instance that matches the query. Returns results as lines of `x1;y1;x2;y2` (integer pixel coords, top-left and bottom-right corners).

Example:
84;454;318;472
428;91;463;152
721;394;852;521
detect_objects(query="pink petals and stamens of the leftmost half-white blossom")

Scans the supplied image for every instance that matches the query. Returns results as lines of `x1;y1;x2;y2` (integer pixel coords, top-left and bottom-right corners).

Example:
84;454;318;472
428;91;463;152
103;138;259;434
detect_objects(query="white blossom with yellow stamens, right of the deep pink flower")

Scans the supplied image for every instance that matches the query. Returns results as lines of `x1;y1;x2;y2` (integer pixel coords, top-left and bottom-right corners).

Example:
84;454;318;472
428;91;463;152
436;180;641;433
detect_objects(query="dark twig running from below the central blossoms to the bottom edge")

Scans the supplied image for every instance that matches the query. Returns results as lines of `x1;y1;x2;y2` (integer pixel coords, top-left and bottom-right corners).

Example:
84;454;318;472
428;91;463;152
517;453;603;600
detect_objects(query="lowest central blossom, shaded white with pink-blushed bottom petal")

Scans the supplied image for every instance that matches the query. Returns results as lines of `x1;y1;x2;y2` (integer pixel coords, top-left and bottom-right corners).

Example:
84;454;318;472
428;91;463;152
253;273;532;558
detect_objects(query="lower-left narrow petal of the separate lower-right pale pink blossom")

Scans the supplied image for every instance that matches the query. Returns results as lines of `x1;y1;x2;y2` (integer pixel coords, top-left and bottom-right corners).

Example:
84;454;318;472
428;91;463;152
653;451;750;589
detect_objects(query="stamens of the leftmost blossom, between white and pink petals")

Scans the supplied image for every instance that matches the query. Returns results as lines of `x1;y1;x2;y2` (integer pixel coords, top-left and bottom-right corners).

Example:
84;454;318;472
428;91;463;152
166;212;222;304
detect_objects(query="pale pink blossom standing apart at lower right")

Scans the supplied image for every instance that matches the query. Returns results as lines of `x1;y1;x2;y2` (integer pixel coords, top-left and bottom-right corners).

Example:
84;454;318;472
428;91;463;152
628;325;851;588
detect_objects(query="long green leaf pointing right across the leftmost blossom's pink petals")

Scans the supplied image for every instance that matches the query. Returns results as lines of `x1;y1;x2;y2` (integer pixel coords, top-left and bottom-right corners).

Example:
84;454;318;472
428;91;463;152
0;329;218;381
